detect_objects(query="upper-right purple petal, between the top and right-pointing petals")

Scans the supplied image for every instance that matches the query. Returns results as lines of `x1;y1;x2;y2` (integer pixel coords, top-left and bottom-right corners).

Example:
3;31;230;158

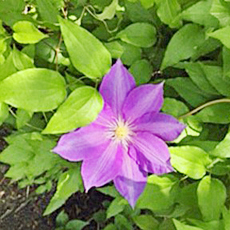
123;83;163;121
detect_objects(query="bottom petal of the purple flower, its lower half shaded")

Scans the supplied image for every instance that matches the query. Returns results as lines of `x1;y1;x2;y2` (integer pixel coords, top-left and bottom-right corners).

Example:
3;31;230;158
114;150;147;208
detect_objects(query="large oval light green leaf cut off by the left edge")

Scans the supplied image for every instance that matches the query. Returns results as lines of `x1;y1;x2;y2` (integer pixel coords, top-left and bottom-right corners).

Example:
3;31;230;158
0;69;66;112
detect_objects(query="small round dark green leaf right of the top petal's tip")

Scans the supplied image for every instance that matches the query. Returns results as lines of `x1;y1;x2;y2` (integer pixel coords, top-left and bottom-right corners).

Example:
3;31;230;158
129;59;153;85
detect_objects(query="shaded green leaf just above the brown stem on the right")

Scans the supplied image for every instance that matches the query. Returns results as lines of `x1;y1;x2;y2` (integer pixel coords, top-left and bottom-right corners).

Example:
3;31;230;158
166;77;212;107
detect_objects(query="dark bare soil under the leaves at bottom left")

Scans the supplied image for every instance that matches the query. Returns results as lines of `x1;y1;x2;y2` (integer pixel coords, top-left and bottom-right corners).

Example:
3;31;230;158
0;126;110;230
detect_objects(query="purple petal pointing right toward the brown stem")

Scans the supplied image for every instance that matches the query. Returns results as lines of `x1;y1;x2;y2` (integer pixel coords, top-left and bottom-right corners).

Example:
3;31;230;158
135;113;186;141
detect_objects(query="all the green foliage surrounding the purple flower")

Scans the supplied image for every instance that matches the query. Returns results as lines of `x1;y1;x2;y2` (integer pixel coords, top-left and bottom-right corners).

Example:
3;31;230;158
0;0;230;230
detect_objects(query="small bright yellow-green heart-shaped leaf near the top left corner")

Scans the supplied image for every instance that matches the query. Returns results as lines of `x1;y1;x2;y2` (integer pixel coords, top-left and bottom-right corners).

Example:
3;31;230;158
13;21;48;44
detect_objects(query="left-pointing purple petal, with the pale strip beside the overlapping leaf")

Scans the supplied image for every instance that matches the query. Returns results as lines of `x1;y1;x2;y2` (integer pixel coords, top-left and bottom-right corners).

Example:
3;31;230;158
53;104;114;161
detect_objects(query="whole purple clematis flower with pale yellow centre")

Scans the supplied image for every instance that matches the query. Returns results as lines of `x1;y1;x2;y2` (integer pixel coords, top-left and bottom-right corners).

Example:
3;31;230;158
53;60;185;207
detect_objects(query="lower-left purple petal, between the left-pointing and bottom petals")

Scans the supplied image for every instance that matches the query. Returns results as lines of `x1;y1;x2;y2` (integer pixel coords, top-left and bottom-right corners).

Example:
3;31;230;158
81;141;124;192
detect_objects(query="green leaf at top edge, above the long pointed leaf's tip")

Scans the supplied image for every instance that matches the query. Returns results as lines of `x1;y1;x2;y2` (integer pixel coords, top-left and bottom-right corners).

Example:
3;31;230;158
36;0;59;23
